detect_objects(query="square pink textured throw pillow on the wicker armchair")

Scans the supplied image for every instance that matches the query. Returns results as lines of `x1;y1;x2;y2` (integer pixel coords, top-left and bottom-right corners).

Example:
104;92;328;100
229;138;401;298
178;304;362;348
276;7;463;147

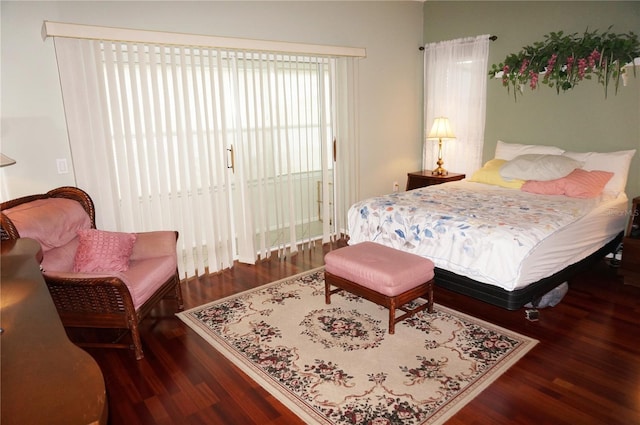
73;229;136;273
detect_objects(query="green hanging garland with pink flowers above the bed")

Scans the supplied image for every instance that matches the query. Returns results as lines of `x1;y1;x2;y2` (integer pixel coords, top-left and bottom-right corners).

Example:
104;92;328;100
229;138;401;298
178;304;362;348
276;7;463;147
489;27;640;99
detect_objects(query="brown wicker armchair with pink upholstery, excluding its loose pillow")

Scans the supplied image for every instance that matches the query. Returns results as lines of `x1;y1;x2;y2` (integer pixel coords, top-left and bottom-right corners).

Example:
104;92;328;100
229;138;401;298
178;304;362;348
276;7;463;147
0;187;183;360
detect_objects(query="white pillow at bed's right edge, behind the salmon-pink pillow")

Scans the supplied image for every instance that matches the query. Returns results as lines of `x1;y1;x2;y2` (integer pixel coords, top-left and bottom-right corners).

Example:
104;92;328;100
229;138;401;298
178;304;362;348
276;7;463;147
563;149;636;196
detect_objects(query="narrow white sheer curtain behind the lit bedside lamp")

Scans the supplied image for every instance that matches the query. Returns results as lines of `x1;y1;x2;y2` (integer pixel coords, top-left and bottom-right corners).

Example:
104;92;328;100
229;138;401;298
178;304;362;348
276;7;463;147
422;34;490;176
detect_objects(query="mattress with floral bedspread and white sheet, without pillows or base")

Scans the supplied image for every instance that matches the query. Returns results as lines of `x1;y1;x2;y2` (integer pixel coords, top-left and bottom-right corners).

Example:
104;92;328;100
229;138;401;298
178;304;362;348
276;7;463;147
348;180;627;291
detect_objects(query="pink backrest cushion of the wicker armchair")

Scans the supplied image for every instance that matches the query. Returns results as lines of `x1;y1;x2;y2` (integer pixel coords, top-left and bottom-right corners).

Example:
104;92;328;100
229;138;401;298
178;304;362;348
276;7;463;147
4;198;91;252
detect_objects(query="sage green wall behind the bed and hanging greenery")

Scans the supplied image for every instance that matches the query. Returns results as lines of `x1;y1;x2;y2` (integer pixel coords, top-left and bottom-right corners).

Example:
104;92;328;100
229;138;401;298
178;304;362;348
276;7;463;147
424;1;640;197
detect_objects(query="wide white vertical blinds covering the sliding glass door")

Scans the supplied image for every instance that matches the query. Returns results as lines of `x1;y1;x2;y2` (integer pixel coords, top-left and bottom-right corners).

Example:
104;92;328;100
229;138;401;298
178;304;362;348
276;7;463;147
47;23;358;276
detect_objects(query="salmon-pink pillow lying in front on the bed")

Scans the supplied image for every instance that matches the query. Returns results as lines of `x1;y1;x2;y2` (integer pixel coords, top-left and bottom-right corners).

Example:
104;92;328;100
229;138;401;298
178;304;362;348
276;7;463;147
521;168;613;198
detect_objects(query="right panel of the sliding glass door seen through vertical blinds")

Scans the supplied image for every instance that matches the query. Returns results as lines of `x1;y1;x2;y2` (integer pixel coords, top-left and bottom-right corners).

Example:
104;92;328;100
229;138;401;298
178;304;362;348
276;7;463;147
229;53;333;262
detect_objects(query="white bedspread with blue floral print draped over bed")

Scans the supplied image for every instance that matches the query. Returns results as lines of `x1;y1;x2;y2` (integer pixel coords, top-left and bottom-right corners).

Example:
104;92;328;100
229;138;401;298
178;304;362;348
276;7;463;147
348;181;597;290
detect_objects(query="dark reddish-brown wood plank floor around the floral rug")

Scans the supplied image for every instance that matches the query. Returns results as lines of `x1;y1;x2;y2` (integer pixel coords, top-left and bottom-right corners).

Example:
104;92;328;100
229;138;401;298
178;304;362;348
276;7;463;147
88;240;640;425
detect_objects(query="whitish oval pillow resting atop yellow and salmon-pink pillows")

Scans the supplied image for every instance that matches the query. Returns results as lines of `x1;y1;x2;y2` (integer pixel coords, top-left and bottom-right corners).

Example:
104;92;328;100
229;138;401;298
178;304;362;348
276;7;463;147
500;154;584;181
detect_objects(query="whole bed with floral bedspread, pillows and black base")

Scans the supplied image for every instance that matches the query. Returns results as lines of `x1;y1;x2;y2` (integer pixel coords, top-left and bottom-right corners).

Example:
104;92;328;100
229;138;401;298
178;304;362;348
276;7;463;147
348;141;635;310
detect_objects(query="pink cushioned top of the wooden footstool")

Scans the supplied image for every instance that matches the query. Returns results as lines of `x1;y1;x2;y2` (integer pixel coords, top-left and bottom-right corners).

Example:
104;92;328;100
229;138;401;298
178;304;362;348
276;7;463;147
324;242;434;297
